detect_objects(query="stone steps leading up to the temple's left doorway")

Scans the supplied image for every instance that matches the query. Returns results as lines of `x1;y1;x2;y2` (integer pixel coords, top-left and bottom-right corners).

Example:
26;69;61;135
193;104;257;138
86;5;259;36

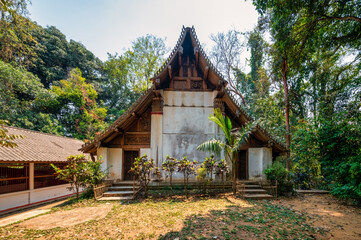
98;181;139;201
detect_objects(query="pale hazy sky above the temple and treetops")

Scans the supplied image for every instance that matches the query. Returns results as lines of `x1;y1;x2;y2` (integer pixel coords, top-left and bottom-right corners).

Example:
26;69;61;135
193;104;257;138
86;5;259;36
28;0;258;70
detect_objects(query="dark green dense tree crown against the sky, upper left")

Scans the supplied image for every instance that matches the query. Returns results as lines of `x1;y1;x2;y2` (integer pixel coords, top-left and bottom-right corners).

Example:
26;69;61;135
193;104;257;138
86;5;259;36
29;25;104;88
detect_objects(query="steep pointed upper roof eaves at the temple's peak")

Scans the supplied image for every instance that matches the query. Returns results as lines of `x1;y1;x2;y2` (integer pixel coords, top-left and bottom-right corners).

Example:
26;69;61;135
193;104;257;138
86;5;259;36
152;26;228;89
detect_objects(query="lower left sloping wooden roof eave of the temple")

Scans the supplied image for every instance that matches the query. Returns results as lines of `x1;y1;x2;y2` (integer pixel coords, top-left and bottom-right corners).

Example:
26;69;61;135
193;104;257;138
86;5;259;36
79;88;154;154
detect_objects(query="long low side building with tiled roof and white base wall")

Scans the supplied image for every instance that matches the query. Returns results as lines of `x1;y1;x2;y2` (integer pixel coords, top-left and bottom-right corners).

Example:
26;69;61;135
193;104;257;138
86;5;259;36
0;126;84;214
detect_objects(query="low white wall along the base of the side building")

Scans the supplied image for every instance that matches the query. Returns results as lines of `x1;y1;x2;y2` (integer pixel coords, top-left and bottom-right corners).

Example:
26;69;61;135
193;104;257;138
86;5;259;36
0;184;73;213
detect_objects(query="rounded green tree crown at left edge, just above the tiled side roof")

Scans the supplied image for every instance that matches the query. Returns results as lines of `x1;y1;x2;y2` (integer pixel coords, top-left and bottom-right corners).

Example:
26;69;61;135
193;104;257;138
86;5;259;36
0;61;63;135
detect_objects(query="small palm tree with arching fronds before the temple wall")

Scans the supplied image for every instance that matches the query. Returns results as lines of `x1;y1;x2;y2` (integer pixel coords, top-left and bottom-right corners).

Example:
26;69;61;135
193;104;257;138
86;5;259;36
197;109;256;194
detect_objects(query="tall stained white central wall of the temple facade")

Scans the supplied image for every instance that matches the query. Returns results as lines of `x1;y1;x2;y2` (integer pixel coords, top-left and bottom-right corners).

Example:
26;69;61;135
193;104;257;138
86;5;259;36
160;91;219;177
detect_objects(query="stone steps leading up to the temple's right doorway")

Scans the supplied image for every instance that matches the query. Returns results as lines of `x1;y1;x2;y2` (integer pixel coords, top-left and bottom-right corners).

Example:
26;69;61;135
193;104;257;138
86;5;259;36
237;181;274;200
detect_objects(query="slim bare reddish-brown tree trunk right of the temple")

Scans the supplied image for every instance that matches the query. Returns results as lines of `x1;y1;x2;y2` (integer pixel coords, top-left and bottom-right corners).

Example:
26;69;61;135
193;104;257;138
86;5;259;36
282;58;291;170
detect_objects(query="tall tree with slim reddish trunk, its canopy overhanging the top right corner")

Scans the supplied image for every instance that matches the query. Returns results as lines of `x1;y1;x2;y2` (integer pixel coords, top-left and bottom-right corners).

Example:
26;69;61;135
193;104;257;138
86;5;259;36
253;0;361;169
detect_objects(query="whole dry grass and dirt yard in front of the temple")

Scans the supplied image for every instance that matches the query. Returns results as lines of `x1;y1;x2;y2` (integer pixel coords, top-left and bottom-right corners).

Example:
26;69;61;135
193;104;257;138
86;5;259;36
0;194;361;240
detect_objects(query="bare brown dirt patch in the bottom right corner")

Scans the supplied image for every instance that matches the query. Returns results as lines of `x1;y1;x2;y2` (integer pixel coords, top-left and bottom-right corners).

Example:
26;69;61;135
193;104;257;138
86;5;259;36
277;194;361;239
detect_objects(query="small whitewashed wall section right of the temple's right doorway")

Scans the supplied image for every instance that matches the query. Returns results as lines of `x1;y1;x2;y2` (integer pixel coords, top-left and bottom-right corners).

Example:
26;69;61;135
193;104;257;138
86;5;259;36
248;148;272;180
